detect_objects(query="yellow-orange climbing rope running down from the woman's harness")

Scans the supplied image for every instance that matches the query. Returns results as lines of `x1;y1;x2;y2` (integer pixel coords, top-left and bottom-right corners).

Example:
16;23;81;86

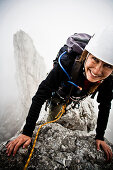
24;104;66;170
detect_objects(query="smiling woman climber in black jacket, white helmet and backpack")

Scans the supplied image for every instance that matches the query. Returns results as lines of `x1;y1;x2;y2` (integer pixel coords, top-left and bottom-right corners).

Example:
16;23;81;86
6;27;113;161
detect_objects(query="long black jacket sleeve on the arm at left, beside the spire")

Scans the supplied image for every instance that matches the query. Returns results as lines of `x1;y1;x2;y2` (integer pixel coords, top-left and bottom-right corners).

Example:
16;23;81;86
23;64;65;137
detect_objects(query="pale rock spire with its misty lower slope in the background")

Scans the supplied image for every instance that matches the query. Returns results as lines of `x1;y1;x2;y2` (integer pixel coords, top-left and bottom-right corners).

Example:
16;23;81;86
0;30;46;143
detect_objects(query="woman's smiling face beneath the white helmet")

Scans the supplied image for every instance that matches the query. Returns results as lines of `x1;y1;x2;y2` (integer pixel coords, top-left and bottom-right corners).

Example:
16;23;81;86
85;54;113;82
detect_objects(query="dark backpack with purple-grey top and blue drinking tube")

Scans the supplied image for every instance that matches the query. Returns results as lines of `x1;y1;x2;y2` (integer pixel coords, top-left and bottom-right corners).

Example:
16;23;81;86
53;33;91;89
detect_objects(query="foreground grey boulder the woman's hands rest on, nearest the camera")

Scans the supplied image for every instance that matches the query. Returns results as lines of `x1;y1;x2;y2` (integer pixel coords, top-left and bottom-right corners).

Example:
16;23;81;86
0;123;113;170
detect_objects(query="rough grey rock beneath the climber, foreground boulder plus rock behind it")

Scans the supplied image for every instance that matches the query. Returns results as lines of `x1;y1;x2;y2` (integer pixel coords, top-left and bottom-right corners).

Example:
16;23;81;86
0;97;113;170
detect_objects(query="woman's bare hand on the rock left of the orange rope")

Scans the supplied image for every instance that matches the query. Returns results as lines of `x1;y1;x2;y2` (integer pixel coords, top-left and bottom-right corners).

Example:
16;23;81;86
6;134;31;156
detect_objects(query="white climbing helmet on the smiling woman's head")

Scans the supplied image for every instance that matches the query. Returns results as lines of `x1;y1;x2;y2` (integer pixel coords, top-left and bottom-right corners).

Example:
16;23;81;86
85;27;113;65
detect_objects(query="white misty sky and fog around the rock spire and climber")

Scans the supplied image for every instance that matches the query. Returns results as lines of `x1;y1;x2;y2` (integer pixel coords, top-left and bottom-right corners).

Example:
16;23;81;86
0;0;113;143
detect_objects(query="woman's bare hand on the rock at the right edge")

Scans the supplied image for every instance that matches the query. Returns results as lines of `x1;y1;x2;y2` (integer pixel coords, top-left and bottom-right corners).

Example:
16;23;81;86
96;139;112;162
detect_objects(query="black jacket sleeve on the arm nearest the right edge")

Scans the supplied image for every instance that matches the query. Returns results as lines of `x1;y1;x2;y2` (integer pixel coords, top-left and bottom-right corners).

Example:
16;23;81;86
96;77;113;140
